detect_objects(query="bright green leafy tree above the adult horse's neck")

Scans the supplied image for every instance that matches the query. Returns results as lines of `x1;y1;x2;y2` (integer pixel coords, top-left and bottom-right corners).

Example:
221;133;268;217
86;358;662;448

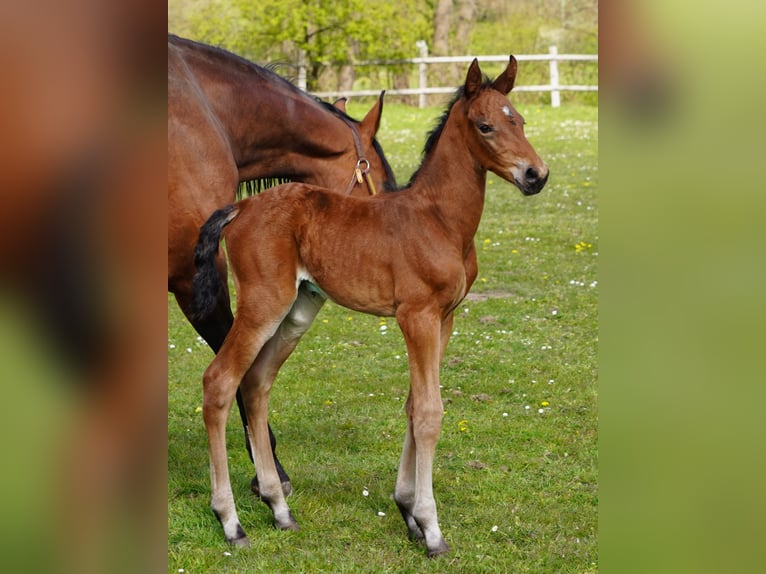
181;0;431;90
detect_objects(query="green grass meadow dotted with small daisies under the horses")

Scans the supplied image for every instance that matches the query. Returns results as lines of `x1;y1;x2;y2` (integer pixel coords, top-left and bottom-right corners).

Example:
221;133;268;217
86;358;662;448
168;104;598;574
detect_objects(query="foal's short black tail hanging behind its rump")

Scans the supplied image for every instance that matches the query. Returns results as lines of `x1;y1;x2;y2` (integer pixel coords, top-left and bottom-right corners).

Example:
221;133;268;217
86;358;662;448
192;205;237;320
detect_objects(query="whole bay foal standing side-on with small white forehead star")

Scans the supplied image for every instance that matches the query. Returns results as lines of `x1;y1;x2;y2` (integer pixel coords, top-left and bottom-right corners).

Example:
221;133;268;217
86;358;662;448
195;56;548;556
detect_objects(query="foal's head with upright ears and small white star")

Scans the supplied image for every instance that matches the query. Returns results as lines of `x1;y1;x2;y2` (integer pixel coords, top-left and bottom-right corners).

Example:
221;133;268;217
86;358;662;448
463;56;548;195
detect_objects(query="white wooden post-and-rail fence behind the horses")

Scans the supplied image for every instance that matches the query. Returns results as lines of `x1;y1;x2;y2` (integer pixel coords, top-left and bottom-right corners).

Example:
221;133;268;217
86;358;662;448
304;42;598;108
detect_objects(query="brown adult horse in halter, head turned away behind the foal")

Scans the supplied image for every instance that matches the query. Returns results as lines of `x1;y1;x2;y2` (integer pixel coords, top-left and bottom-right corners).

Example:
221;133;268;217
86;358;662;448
168;35;395;493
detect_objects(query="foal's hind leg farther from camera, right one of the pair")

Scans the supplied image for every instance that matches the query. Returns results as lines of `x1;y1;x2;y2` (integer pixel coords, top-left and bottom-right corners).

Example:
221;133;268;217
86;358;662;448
242;283;325;530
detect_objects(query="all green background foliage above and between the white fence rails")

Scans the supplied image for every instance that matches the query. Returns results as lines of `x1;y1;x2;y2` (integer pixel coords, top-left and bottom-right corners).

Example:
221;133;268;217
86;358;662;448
168;0;598;99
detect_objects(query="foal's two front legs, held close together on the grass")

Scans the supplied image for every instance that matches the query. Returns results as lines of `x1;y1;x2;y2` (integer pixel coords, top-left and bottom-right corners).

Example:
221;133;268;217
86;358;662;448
394;306;449;557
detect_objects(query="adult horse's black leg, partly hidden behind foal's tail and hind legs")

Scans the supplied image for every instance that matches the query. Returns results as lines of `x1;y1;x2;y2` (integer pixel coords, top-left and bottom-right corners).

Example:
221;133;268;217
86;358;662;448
172;257;292;496
